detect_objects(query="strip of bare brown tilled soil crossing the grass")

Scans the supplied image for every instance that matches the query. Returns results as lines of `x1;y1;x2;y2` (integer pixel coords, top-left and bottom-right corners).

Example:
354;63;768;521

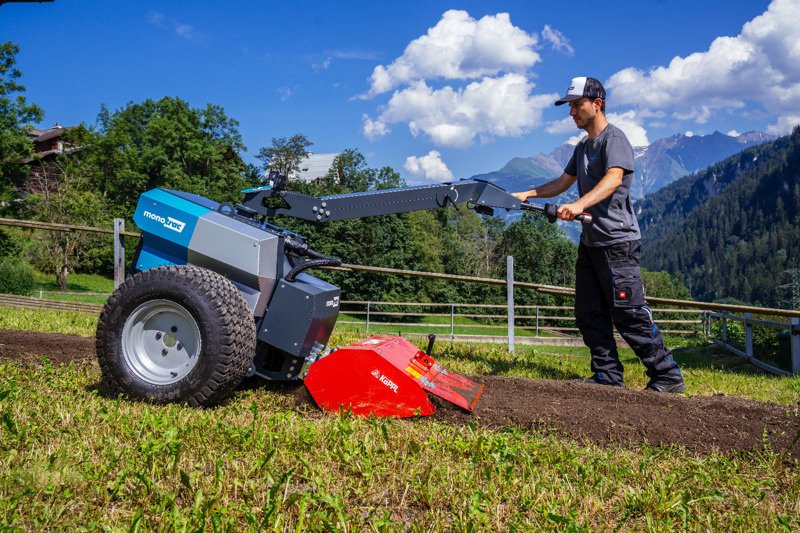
0;330;800;458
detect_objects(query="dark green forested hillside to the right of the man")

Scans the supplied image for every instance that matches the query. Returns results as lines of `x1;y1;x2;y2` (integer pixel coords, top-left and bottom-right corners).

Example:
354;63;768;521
638;128;800;307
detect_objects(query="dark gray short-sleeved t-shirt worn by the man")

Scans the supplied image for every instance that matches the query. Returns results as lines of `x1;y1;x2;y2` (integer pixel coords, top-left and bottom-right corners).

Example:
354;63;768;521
564;124;641;246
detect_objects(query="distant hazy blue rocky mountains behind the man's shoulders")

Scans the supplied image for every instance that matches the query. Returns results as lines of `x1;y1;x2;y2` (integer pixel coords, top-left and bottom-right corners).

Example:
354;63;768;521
473;131;775;203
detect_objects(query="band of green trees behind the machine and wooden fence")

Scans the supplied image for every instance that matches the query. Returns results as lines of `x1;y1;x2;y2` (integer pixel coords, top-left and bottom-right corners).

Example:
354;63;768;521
0;43;687;304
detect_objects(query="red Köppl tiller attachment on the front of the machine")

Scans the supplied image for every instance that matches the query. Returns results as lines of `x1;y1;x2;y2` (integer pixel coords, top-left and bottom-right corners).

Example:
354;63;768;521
305;335;483;418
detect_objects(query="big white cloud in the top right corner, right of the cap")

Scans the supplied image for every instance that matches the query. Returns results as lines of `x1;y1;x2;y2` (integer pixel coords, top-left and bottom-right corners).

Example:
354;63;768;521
606;0;800;133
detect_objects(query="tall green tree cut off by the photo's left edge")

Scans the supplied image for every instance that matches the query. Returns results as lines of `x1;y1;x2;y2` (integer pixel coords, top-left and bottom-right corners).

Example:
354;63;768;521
0;42;44;211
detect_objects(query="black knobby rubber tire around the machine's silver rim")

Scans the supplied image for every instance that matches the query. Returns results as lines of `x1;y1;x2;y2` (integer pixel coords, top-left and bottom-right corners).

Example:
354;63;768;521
96;266;256;406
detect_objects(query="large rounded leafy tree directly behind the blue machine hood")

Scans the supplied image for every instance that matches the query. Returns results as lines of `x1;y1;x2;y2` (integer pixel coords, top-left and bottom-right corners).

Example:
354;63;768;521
80;97;252;218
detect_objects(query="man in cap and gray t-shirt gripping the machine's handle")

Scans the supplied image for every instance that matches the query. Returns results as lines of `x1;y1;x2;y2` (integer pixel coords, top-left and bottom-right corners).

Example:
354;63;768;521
514;77;686;393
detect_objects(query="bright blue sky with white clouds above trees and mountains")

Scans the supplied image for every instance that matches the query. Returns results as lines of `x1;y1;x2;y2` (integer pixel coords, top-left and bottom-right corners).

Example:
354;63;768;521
0;0;800;183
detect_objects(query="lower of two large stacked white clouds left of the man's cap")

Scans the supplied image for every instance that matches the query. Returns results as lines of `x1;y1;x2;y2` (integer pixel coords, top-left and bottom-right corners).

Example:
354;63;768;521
363;73;558;148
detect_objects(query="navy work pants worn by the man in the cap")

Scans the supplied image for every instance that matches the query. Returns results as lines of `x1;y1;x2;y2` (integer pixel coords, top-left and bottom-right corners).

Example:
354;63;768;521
575;240;677;385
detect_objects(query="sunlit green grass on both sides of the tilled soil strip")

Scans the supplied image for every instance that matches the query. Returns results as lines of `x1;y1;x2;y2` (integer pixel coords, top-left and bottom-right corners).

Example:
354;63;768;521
0;308;800;531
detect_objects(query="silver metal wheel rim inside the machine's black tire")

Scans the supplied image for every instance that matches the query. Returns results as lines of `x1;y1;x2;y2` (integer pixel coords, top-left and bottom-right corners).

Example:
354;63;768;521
122;300;202;385
